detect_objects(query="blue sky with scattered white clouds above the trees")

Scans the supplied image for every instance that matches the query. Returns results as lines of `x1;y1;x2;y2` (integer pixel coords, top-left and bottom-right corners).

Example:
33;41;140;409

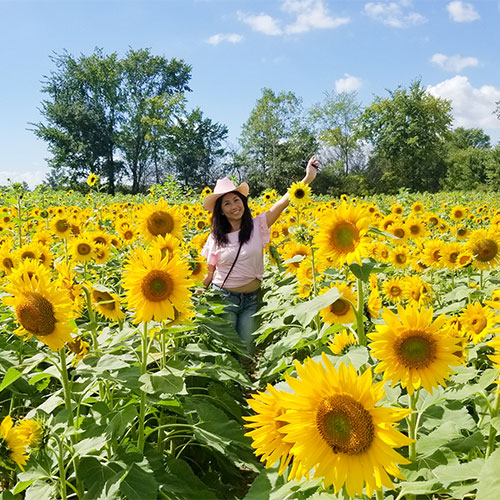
0;0;500;186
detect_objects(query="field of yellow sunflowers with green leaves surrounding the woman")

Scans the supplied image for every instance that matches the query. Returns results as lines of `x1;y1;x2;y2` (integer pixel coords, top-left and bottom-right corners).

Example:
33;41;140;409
0;178;500;500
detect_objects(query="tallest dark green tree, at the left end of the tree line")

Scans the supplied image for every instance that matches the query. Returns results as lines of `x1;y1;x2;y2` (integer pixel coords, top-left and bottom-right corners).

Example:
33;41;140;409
34;49;191;193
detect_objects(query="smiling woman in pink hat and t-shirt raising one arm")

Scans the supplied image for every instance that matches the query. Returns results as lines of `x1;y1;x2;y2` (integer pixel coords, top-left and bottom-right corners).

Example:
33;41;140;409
201;156;318;356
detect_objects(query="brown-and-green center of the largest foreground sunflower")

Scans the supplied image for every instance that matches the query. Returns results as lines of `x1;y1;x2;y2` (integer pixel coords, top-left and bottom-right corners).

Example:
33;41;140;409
316;394;375;455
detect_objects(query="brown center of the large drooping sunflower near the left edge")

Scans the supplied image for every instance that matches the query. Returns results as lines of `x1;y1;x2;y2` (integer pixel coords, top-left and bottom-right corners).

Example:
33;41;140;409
16;292;56;337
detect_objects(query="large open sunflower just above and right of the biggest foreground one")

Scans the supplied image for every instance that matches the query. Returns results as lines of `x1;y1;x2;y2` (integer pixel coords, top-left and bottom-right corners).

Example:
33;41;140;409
368;304;461;395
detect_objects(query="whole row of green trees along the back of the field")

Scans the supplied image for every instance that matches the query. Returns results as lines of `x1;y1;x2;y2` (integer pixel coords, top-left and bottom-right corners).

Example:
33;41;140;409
32;49;500;195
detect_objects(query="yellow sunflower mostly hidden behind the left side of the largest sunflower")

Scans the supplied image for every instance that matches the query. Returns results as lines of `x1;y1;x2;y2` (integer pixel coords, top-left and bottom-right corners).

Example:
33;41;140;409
243;384;306;480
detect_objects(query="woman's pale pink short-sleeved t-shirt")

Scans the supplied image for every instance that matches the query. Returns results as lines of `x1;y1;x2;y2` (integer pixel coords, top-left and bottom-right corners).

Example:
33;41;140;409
201;212;270;288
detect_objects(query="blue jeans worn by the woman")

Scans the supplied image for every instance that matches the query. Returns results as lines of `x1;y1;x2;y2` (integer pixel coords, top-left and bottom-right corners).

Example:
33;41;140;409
212;283;259;356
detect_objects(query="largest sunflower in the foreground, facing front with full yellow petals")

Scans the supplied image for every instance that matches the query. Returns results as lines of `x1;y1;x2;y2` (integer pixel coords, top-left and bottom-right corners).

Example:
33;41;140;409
280;353;411;497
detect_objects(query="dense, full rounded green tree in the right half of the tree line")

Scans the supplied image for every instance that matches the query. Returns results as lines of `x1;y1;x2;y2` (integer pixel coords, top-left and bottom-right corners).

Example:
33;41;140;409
361;81;452;192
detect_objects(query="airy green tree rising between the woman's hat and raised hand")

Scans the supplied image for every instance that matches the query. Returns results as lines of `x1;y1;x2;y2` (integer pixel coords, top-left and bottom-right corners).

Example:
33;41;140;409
240;88;317;192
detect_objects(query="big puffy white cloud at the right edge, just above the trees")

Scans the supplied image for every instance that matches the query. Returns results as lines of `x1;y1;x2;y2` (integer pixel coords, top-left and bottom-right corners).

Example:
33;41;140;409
427;75;500;130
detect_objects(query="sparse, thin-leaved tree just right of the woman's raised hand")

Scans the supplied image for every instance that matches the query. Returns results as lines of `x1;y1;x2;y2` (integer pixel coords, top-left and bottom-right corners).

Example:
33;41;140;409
309;92;364;174
